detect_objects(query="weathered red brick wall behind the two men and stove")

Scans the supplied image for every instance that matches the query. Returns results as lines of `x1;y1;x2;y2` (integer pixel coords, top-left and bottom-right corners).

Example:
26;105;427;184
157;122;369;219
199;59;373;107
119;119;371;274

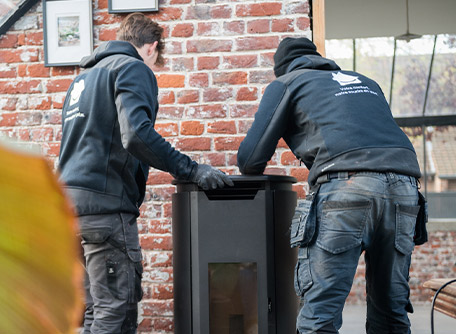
0;0;456;333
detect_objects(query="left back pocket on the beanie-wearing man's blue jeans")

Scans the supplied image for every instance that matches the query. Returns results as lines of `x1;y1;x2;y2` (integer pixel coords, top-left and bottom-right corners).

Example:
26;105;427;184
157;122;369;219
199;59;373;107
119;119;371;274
317;200;371;254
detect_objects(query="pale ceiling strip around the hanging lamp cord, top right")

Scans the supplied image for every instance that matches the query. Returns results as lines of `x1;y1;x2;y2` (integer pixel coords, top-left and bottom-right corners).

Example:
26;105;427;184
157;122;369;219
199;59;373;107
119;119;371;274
325;0;456;39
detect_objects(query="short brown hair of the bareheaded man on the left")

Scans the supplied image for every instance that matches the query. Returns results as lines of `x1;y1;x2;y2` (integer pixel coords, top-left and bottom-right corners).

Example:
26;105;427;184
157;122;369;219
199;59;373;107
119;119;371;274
117;13;165;65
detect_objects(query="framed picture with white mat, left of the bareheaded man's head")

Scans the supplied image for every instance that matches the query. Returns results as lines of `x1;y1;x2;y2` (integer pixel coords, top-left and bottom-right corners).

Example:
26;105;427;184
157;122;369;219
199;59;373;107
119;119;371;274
43;0;93;66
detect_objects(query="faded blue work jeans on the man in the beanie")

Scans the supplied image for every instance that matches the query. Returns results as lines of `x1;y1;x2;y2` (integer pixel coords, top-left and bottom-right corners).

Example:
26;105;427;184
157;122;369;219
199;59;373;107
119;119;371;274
295;172;419;334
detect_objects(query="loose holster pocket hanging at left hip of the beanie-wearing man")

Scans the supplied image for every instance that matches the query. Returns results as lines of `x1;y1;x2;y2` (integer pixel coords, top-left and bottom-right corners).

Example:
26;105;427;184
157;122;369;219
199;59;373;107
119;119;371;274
290;197;316;247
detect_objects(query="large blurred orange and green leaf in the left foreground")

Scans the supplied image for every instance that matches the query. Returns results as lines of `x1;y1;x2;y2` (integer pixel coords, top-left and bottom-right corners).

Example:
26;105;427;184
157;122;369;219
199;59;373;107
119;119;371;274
0;146;82;334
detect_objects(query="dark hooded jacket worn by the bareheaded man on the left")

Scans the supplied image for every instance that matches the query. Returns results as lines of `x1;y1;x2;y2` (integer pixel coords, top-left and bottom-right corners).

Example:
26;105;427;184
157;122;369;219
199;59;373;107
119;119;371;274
59;41;197;215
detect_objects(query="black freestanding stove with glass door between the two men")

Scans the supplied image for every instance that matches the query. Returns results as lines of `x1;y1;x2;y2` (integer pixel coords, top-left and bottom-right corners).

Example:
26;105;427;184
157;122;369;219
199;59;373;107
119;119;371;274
173;175;298;334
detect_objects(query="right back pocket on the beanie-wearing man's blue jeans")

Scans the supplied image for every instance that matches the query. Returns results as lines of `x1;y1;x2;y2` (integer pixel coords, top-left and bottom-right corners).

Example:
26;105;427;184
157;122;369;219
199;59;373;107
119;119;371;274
394;204;420;255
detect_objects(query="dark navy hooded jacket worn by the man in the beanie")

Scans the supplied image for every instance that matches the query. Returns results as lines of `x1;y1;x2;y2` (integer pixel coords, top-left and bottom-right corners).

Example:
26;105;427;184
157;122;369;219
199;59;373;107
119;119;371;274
238;55;421;186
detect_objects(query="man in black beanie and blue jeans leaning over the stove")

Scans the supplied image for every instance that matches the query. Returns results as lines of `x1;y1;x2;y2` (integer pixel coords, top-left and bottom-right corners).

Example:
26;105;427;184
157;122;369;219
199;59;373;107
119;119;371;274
238;38;421;334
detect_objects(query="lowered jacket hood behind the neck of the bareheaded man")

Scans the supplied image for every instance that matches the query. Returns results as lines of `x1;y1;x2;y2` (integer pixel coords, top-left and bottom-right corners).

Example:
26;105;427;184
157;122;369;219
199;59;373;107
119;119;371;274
79;41;143;68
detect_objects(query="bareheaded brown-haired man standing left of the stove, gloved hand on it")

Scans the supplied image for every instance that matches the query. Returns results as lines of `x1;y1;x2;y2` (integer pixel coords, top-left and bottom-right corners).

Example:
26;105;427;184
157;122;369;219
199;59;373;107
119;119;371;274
59;13;232;334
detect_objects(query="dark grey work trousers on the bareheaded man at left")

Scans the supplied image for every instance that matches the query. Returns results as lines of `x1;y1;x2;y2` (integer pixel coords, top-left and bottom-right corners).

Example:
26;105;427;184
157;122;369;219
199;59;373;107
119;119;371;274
79;214;143;334
